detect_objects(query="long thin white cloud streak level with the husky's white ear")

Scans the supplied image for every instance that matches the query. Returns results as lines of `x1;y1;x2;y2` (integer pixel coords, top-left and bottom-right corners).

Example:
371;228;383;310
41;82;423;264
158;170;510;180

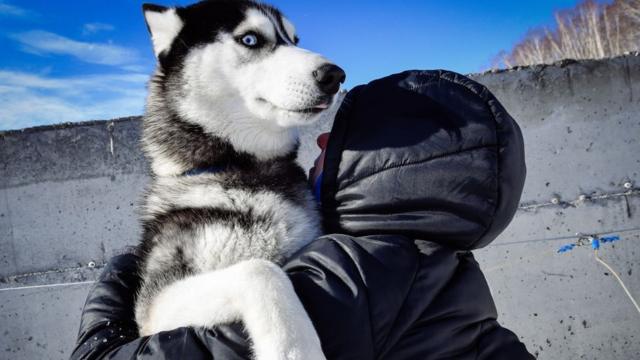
10;30;139;66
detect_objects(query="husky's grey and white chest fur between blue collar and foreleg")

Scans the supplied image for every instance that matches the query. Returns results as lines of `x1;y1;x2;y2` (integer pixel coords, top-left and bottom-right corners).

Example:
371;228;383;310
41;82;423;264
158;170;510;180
142;160;319;272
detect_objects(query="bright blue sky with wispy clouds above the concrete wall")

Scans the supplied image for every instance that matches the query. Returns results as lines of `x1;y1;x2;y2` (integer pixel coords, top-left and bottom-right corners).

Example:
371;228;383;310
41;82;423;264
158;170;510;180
0;0;577;130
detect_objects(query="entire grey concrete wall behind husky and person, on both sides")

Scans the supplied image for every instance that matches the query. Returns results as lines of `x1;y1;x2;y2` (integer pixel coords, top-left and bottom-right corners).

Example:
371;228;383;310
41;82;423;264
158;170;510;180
0;55;640;359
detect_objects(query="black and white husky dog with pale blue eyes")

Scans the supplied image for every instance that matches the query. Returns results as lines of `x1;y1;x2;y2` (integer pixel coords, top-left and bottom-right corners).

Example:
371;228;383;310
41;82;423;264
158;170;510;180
135;0;345;359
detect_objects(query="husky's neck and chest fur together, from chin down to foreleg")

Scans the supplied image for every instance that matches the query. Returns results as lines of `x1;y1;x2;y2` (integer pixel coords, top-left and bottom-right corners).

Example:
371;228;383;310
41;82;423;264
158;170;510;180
136;95;320;324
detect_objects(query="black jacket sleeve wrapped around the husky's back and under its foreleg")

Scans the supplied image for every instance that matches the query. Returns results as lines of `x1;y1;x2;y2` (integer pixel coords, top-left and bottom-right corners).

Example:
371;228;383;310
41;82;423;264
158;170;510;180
71;254;251;360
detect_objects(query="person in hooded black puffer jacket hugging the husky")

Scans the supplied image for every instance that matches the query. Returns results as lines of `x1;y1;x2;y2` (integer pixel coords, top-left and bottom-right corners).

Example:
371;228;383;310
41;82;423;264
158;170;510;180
71;71;533;360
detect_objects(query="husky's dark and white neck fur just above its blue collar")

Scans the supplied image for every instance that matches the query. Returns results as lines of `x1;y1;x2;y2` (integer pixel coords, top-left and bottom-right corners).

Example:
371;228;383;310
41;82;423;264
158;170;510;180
142;88;298;176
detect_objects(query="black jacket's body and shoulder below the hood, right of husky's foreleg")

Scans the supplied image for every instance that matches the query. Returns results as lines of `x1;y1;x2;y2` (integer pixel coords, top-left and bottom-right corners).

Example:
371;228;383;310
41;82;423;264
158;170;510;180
284;235;533;360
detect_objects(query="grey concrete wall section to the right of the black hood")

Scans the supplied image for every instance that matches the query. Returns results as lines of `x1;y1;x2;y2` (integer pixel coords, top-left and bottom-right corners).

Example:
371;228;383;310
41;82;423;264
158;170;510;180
464;56;640;359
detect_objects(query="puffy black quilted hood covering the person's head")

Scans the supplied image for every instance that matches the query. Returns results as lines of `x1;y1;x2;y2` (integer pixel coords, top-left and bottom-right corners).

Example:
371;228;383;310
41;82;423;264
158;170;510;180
322;71;526;250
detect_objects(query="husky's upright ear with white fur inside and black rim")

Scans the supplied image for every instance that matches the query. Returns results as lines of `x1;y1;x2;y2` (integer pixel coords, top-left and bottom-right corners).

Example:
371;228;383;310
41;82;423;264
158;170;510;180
142;4;184;57
